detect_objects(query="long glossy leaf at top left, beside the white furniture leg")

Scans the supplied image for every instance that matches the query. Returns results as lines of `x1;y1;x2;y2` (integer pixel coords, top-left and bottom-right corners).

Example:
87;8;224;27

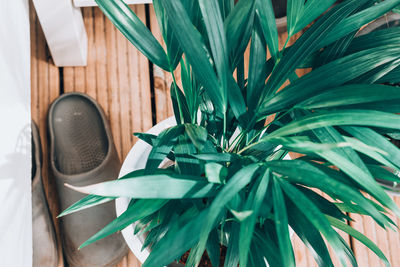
96;0;170;71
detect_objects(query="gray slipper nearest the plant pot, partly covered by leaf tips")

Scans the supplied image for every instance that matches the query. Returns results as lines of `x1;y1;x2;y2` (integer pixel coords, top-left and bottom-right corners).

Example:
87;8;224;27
48;93;128;267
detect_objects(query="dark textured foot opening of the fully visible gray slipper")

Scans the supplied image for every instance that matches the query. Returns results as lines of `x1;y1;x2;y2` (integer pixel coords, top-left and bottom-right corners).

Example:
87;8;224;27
52;94;108;175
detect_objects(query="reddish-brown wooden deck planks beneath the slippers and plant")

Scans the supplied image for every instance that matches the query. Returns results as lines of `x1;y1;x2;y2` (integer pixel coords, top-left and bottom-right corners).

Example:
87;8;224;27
30;2;400;267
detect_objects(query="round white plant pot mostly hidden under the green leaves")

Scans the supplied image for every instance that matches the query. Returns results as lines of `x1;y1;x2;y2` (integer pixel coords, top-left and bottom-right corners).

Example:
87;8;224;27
115;117;293;263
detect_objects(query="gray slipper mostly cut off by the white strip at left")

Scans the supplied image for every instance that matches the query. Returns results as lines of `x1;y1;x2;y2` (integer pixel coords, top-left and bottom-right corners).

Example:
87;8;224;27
32;121;58;267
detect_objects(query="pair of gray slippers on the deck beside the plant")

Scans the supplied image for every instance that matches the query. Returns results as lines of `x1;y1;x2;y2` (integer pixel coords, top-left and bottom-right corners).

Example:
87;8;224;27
32;93;128;267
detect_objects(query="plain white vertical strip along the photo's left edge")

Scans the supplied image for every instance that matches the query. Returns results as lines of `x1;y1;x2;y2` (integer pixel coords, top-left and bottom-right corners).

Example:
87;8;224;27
0;0;32;267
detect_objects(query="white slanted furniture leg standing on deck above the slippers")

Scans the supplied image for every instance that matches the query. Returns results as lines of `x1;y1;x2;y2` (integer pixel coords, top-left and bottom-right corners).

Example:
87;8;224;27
33;0;87;66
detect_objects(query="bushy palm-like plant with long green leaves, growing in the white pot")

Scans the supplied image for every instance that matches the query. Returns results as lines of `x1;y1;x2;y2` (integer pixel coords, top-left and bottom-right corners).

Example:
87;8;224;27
62;0;400;267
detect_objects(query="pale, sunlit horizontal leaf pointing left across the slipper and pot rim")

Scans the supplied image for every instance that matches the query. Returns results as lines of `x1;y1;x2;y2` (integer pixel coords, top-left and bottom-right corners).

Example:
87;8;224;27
65;173;215;199
